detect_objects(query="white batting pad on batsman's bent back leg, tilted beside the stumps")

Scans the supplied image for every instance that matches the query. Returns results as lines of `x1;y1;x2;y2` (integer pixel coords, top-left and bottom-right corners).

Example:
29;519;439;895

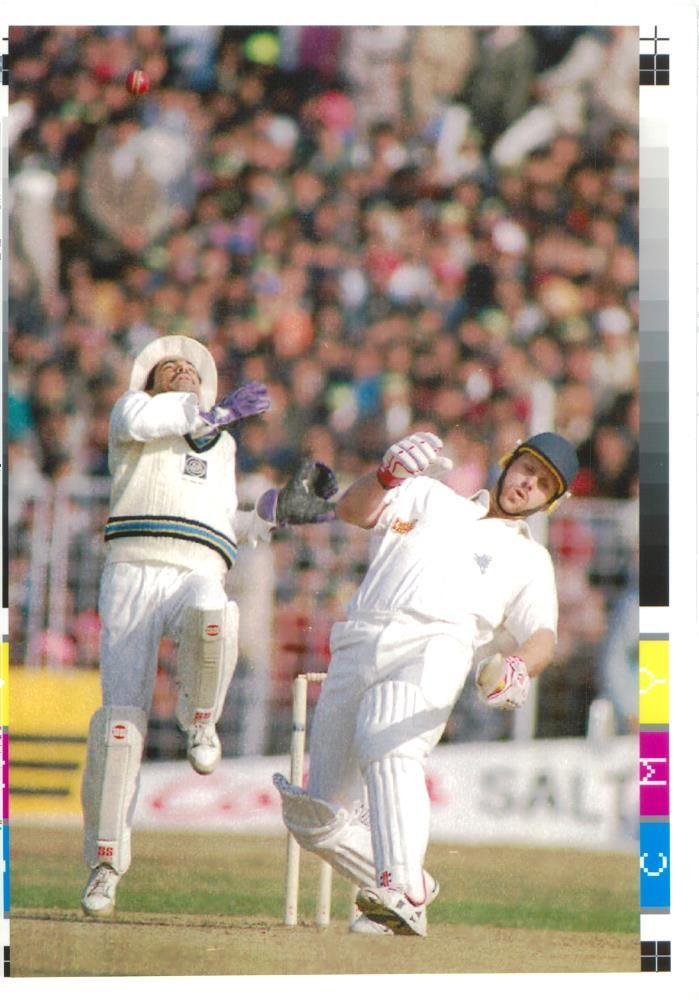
273;774;375;885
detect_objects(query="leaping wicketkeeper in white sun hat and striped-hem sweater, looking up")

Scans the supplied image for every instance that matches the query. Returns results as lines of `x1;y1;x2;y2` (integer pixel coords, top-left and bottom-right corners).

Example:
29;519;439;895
82;336;337;917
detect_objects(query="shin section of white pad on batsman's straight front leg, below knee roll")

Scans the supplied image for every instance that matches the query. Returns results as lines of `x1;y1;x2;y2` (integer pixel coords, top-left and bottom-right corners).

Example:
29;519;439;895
364;757;430;903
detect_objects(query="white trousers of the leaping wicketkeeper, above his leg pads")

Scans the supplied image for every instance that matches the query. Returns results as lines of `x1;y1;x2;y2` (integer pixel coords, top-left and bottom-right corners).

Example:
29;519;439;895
99;562;227;714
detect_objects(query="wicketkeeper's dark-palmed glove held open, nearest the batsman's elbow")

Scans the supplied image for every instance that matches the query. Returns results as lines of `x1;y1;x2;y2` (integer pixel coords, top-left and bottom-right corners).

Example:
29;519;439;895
256;458;337;527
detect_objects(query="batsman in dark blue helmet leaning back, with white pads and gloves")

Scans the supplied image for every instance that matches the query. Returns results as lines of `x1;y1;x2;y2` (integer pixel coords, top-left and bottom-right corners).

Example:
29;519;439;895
274;432;578;936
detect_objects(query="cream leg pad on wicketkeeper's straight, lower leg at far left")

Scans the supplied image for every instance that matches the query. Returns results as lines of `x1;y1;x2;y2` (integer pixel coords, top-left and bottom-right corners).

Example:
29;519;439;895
82;706;148;874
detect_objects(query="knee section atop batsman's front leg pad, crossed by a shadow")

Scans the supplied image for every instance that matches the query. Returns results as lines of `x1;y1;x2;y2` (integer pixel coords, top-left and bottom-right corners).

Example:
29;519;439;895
355;681;450;771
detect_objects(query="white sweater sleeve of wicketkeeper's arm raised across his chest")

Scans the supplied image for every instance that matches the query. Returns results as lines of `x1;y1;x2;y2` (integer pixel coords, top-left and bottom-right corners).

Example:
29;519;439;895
111;391;206;441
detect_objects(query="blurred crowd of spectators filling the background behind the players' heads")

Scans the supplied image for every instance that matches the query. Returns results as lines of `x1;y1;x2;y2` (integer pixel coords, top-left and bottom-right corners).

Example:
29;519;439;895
7;26;639;748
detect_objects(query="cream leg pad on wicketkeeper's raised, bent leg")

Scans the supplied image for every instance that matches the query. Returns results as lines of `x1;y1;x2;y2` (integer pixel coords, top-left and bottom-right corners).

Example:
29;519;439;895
177;601;238;729
